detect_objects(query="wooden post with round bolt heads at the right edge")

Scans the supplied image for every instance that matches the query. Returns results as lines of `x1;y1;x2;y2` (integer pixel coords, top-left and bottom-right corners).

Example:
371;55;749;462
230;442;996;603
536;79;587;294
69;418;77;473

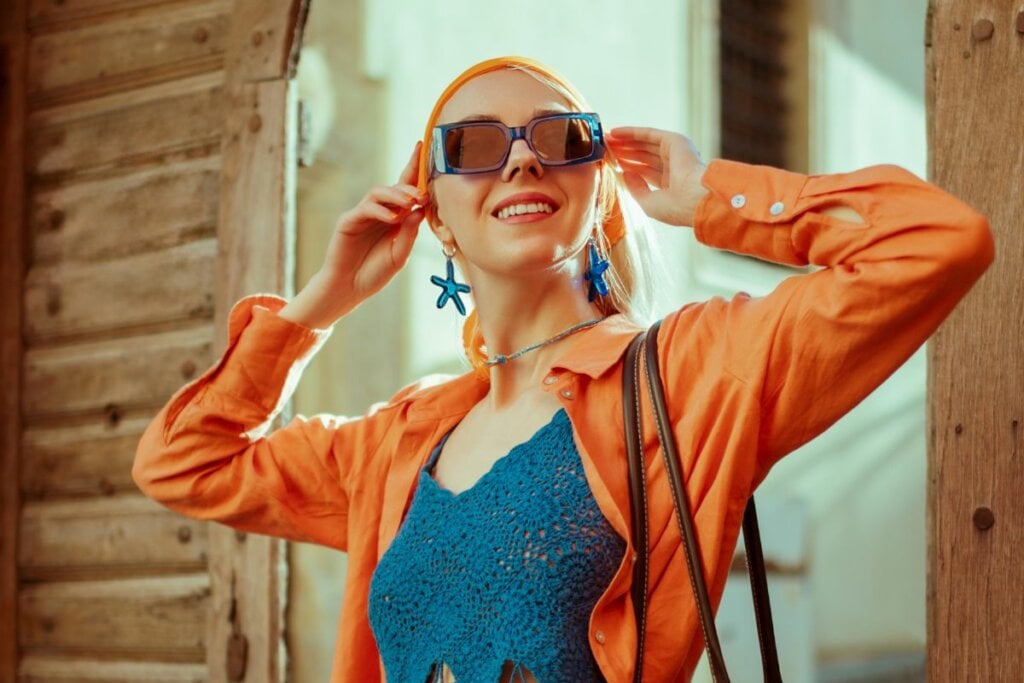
926;0;1024;681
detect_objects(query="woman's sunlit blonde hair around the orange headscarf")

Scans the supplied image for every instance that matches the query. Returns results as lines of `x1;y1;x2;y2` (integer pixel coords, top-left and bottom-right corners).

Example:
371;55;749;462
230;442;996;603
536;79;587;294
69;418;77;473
421;58;655;379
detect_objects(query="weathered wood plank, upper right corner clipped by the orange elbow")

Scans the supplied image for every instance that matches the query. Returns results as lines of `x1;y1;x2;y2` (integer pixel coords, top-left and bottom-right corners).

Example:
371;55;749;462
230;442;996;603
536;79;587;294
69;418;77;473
17;495;208;581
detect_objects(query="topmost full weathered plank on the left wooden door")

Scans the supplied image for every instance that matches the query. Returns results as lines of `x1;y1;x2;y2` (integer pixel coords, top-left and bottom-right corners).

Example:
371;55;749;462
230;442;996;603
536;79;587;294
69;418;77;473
29;0;230;106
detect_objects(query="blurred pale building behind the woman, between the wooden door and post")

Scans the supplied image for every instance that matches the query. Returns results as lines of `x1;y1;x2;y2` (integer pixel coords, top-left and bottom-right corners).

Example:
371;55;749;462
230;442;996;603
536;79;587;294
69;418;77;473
288;0;927;683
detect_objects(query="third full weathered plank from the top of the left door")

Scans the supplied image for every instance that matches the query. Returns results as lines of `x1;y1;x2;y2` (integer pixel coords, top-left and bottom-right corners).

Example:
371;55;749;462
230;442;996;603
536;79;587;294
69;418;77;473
29;157;220;265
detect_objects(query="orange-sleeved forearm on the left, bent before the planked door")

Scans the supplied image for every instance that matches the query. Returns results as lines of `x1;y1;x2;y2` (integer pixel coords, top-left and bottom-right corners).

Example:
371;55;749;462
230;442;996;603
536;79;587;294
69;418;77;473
132;297;330;521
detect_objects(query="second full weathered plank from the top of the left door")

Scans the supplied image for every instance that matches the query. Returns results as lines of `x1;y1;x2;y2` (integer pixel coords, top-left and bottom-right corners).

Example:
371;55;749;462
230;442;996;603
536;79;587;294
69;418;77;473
28;79;223;176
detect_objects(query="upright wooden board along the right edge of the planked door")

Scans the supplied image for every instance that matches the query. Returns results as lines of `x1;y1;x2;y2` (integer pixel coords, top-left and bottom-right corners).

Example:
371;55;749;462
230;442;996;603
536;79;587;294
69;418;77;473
207;0;308;682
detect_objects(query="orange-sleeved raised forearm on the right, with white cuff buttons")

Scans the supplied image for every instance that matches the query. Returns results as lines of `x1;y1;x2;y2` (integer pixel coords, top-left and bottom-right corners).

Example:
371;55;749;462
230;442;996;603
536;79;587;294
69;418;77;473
694;161;992;270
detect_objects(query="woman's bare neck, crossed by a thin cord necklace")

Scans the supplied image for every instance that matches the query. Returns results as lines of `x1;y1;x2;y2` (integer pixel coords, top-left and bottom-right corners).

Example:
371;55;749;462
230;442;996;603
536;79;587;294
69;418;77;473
473;268;601;410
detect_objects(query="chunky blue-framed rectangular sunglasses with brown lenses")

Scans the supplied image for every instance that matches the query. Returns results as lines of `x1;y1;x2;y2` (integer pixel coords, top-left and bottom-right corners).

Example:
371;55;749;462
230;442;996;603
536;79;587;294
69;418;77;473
431;113;604;174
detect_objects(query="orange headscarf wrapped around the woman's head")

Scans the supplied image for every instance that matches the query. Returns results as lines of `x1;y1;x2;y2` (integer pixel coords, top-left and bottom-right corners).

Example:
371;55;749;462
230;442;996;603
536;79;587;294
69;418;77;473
417;56;626;380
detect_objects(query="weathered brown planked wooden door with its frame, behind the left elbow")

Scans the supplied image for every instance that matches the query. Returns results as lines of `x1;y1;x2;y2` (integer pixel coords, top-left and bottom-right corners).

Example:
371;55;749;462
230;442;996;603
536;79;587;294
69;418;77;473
0;0;304;683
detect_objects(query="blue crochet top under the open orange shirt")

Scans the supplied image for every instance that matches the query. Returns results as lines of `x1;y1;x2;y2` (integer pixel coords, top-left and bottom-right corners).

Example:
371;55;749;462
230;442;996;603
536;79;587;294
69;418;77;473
369;410;626;683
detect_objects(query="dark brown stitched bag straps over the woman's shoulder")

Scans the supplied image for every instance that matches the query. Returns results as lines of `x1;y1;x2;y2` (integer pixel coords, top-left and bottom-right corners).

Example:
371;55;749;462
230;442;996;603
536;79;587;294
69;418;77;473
623;322;782;683
